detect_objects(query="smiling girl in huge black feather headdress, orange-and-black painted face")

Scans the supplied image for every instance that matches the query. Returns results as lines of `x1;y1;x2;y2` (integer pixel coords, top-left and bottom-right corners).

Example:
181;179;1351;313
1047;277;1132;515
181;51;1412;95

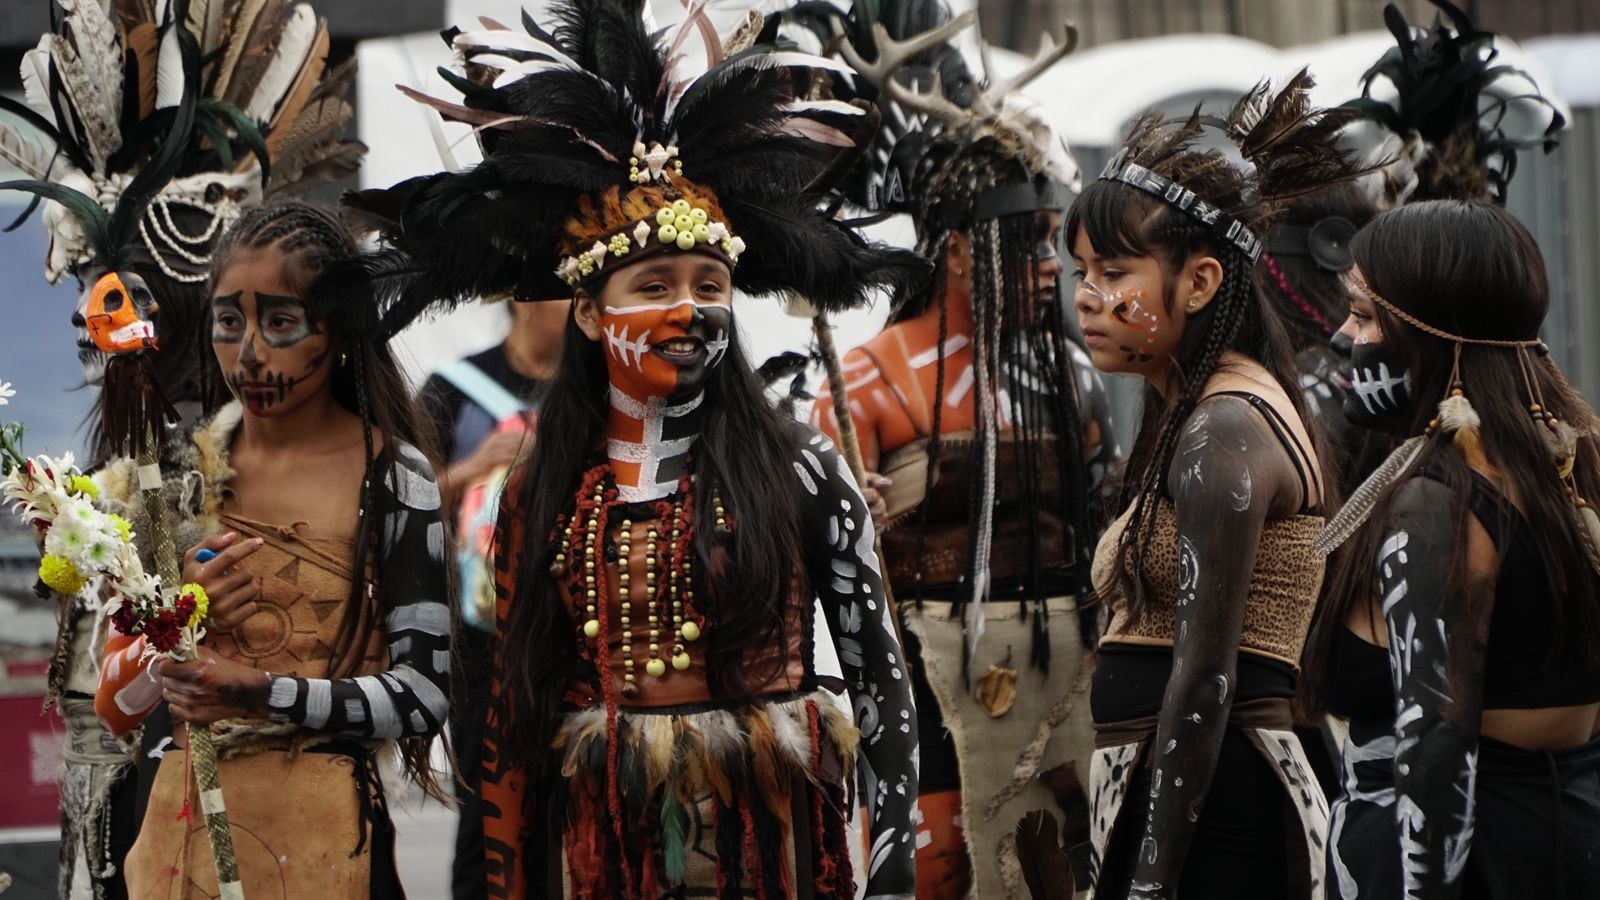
350;0;923;900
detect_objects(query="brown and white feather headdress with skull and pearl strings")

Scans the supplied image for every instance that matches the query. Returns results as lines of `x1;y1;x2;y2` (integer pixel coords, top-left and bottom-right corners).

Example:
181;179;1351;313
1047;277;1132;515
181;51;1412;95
0;0;365;283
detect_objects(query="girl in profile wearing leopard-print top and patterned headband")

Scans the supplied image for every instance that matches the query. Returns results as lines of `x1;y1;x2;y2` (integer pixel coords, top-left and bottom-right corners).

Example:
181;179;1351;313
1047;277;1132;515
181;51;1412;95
1066;72;1357;898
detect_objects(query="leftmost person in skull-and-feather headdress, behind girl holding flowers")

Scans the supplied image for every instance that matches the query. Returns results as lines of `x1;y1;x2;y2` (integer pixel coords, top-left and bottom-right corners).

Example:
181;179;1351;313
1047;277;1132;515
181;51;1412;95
0;0;365;897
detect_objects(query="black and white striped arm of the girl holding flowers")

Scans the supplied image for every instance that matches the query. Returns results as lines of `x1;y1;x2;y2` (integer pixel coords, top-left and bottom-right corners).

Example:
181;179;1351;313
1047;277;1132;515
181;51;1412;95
267;444;450;738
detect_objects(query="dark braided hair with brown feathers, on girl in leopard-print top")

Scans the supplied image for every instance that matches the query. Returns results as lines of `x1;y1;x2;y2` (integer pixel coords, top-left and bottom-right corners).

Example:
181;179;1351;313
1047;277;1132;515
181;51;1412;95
1064;70;1360;620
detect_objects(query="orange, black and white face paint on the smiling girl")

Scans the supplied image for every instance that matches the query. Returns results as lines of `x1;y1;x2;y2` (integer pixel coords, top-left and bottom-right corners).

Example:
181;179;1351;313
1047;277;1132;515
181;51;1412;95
600;299;733;402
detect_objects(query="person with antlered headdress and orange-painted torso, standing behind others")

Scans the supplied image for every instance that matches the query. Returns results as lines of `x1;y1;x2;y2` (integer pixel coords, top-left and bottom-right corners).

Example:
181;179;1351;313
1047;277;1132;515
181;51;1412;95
797;0;1117;900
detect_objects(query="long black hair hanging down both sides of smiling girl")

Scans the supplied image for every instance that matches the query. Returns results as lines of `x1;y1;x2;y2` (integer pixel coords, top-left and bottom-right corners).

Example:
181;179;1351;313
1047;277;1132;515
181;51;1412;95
496;297;805;773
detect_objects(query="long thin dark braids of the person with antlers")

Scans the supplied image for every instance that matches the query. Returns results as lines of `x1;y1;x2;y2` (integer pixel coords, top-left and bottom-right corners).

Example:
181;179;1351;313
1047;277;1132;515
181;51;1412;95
890;133;1091;676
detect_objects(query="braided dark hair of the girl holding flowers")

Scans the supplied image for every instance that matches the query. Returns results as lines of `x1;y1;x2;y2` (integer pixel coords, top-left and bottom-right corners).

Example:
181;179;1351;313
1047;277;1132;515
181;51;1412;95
211;200;440;794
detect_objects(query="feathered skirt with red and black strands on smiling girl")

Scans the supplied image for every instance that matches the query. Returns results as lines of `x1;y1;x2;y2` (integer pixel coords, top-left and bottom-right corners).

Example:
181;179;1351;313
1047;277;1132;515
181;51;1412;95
540;693;859;900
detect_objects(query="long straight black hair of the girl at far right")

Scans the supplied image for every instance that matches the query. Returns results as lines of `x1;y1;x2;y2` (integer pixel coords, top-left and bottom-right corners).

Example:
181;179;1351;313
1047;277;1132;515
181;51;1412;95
1304;200;1600;695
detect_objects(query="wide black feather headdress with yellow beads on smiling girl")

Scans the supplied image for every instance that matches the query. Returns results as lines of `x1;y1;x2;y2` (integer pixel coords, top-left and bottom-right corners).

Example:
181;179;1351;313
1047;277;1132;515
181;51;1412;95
331;0;923;336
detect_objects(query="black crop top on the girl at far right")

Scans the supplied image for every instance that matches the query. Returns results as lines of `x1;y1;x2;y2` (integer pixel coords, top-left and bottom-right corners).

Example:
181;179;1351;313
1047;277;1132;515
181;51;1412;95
1317;472;1600;719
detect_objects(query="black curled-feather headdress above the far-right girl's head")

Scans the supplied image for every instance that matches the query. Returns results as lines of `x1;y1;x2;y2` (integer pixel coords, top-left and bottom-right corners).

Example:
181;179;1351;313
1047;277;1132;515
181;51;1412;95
1346;0;1566;208
